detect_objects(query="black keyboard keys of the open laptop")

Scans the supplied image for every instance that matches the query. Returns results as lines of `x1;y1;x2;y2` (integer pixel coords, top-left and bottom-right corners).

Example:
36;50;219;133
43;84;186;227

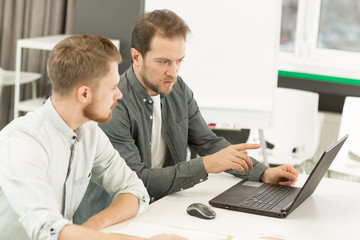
240;184;296;210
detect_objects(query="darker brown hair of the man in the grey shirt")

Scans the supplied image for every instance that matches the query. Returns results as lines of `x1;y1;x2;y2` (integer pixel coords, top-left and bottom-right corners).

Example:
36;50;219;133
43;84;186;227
131;9;190;57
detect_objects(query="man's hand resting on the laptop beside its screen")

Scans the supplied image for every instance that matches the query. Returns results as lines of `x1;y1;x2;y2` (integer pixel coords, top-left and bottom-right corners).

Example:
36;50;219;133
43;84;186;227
260;165;298;186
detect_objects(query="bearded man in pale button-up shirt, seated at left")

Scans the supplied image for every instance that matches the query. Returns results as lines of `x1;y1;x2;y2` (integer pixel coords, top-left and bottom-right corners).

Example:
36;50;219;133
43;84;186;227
0;35;186;240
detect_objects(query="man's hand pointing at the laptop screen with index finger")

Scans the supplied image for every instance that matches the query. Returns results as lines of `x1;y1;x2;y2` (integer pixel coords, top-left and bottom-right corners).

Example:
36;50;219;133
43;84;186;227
203;143;260;173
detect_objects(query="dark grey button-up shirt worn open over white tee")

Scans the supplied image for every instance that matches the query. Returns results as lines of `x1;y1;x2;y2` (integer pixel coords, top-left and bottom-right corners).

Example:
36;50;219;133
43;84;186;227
99;67;266;198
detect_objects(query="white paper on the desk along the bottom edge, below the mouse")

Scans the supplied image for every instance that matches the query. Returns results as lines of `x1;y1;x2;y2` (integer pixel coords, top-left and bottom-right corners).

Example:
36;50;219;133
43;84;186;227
111;222;232;240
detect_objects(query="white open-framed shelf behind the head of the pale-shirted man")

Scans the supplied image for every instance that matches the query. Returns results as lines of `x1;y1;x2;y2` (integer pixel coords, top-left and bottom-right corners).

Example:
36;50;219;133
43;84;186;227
14;35;120;118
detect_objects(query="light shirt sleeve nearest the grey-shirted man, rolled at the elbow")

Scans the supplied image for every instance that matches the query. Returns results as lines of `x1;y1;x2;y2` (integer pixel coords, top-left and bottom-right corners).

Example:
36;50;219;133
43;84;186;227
92;127;150;213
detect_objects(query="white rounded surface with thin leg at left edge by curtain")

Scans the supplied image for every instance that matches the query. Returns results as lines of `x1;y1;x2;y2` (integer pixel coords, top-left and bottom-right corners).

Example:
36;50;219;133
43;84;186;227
0;68;41;102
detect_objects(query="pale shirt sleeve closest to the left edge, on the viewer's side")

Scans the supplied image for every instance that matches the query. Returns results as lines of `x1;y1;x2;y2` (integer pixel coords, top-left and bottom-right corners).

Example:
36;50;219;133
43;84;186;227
0;131;72;239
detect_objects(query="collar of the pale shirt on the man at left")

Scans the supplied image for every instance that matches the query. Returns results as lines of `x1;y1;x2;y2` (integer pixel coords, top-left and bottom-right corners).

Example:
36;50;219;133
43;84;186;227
44;98;82;145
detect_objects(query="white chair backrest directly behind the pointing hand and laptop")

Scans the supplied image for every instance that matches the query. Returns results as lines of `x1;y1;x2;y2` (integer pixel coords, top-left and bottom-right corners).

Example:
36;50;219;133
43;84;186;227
264;88;319;159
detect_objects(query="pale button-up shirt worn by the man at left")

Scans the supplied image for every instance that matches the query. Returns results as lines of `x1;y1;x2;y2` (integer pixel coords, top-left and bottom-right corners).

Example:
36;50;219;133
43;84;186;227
0;99;149;239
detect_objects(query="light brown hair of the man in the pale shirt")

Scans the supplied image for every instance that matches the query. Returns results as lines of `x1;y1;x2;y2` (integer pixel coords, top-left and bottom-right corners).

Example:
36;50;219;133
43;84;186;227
47;34;121;95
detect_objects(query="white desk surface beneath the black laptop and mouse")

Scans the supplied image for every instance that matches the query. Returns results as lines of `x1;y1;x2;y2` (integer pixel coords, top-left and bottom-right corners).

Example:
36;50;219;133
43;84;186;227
103;173;360;240
